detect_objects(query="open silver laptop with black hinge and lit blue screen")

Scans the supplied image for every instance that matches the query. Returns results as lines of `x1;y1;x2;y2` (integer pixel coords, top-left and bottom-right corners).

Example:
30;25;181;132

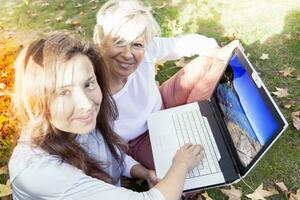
148;46;288;192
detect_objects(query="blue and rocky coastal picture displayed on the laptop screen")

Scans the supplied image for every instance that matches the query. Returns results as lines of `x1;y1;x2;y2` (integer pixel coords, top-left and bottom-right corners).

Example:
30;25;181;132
215;55;278;167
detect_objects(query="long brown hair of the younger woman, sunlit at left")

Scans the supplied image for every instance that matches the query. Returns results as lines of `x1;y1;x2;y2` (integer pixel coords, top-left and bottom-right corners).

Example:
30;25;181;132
14;33;125;183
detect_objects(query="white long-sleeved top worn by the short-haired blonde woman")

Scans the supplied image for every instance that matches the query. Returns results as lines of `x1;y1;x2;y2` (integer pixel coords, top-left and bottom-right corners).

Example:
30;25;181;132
113;34;219;142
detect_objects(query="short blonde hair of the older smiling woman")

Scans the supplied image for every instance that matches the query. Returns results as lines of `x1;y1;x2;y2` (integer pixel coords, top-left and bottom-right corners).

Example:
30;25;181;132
94;0;160;45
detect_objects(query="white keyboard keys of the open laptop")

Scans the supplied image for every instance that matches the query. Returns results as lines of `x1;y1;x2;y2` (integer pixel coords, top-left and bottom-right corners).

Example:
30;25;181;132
173;109;221;178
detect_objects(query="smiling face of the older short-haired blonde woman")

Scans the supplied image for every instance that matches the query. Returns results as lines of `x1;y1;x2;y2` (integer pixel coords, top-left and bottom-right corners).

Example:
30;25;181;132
103;36;146;79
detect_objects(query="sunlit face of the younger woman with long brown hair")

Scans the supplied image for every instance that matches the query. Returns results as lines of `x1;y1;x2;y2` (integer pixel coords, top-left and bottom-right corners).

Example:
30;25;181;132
50;54;102;134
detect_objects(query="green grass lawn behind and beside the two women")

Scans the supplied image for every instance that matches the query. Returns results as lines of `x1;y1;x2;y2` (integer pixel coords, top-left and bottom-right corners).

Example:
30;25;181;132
0;0;300;199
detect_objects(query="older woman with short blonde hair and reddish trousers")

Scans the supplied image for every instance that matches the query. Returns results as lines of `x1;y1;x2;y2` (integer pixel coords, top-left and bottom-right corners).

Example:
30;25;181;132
94;0;237;169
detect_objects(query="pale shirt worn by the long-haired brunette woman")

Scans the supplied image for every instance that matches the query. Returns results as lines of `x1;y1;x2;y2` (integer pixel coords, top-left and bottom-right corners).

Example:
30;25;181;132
9;131;164;200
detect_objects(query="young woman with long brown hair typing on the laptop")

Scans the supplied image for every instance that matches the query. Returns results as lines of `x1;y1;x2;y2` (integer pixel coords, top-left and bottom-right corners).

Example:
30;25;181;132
9;33;201;200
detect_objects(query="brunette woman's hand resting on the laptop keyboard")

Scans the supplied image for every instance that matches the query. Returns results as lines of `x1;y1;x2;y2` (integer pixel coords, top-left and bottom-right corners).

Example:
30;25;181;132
173;144;203;171
